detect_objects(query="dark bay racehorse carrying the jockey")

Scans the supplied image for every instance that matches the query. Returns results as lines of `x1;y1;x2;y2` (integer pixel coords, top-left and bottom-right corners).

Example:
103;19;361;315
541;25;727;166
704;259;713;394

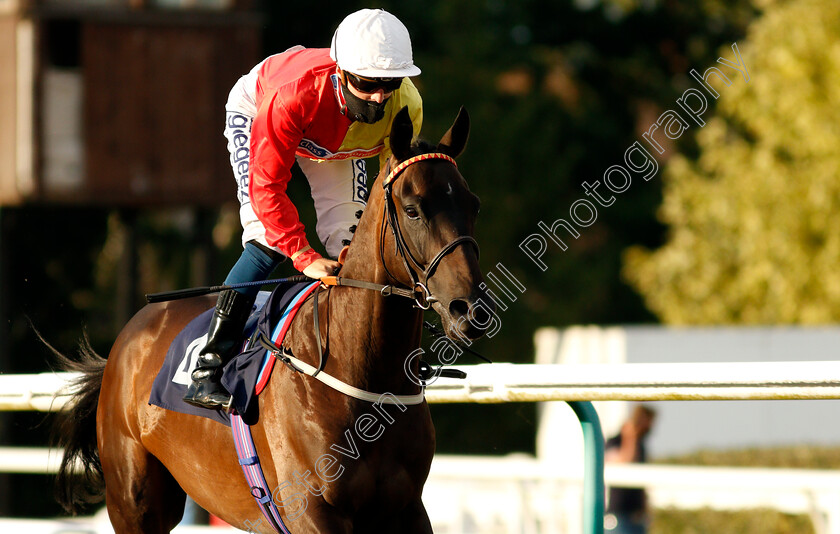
56;108;489;534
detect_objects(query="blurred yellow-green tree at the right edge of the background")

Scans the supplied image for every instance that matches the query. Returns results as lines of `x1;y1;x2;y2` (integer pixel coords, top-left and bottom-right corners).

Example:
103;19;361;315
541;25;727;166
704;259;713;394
624;0;840;324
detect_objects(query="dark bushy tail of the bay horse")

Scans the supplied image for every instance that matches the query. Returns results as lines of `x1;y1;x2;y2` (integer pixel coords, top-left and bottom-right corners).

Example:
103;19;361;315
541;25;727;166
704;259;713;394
47;336;107;513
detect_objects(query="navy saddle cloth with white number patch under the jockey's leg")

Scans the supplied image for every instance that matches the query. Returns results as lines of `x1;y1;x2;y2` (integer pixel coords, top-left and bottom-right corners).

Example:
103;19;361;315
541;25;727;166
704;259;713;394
149;282;311;426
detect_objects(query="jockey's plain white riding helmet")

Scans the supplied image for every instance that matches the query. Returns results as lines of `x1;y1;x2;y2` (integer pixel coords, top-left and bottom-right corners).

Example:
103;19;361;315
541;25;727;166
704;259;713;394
330;9;420;78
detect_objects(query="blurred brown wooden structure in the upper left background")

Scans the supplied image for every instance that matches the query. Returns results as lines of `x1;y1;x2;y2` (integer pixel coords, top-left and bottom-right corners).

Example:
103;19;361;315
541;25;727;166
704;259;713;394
0;0;261;207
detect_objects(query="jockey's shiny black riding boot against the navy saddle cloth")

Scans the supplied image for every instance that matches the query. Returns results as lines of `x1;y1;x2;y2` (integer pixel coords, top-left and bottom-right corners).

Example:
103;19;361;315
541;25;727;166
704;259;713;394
184;289;254;410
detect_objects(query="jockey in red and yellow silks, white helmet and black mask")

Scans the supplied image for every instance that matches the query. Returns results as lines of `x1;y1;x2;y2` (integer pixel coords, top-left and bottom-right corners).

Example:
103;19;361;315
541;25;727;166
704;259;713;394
184;9;423;408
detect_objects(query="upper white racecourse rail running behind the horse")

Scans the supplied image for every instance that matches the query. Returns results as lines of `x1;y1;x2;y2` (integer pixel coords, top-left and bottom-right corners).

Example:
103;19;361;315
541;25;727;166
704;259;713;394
0;361;840;411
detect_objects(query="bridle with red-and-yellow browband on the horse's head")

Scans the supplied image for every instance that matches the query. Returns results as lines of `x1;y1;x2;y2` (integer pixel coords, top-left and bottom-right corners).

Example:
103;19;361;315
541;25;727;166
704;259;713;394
379;152;479;310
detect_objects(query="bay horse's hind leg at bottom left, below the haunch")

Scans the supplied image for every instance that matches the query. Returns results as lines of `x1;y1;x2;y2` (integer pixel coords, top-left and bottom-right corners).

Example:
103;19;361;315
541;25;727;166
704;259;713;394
101;440;186;534
